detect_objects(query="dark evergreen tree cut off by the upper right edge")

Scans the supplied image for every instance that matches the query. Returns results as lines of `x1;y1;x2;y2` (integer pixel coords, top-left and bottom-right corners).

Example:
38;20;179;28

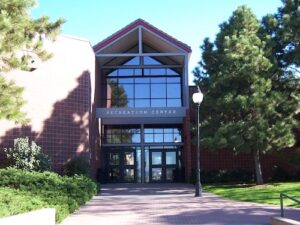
259;0;300;121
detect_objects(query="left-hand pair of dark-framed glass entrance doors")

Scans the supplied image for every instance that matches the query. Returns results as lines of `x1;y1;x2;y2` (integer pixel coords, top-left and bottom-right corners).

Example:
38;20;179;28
106;149;137;182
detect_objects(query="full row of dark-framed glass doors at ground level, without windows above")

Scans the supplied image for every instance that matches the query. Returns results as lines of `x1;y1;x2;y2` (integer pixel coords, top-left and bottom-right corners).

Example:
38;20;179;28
104;146;182;183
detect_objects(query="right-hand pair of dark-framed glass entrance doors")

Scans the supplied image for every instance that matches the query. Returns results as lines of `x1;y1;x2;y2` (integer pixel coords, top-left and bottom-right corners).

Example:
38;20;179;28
149;149;178;182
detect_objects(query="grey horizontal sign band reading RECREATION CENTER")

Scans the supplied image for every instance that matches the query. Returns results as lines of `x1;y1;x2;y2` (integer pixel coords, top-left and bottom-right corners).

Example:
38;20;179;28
97;107;186;118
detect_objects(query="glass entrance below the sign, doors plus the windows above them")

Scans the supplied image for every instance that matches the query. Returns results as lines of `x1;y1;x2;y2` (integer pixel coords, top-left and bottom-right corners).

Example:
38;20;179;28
102;125;183;183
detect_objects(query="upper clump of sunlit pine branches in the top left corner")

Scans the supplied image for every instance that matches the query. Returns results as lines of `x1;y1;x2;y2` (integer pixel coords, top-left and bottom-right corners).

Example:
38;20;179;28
0;0;64;71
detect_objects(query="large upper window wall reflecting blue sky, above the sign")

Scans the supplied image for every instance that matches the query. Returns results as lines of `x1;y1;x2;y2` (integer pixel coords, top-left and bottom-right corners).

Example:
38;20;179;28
102;57;182;108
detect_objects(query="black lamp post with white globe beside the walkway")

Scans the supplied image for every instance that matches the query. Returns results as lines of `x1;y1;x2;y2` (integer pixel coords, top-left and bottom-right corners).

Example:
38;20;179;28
193;87;203;197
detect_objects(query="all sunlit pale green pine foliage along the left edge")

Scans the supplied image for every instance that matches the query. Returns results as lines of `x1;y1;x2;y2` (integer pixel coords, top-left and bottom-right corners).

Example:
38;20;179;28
0;0;64;122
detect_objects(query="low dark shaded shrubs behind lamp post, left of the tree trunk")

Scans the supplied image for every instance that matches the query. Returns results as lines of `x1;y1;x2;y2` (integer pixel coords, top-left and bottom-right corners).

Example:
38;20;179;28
190;169;254;184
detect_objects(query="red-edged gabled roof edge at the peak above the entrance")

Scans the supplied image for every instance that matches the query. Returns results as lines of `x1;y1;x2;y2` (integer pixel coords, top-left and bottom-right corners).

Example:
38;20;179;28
93;19;192;53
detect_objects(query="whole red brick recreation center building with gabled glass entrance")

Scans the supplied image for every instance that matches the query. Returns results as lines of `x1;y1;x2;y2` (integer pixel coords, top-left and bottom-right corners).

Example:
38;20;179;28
0;19;297;183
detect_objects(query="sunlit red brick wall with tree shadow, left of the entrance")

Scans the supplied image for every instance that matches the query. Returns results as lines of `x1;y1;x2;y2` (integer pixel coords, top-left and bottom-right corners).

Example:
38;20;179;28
0;36;95;172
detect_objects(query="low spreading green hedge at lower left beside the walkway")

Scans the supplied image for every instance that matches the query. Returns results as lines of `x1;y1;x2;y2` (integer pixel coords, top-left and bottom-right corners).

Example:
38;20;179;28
0;168;98;222
